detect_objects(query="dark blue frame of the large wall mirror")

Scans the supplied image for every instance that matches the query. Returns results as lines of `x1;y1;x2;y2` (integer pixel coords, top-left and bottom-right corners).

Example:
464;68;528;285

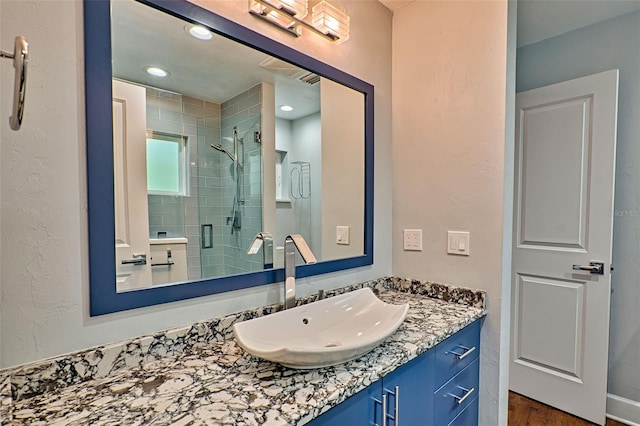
83;0;374;316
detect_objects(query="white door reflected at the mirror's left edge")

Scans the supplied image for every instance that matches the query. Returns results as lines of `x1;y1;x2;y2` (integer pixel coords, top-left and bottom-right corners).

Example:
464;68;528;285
113;80;151;291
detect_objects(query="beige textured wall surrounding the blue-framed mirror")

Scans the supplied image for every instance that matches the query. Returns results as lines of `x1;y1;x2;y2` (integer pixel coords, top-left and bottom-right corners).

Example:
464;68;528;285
0;0;392;367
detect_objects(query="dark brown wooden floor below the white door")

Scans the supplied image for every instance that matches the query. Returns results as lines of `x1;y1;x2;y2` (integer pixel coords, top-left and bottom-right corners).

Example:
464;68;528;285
509;392;624;426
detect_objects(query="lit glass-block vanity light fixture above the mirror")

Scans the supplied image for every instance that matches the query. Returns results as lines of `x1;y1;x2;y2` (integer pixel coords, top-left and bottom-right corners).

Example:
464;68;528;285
249;0;350;43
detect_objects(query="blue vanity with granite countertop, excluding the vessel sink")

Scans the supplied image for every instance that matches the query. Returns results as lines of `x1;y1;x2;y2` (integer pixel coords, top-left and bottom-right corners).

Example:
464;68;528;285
0;278;486;426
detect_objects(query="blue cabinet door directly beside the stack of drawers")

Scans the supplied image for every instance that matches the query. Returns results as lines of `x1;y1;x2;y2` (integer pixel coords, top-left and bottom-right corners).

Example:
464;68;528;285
382;351;434;426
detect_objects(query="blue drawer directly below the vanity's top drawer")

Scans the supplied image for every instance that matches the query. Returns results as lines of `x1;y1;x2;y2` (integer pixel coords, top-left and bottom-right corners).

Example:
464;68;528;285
433;358;479;425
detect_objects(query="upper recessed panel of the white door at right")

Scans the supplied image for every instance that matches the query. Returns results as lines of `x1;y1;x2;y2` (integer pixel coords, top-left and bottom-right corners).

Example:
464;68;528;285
517;97;592;249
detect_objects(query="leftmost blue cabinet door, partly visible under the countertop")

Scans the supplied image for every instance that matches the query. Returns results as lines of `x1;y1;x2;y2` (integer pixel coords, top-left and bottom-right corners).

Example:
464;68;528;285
308;380;382;426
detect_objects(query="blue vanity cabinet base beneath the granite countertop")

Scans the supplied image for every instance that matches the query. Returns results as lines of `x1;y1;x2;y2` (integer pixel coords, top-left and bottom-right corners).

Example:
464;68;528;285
309;321;480;426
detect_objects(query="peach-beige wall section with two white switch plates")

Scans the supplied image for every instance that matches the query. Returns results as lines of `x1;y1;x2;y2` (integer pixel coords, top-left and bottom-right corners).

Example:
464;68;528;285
392;1;513;425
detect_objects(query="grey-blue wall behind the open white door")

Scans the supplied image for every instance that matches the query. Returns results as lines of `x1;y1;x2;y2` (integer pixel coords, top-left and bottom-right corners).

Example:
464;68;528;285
517;12;640;412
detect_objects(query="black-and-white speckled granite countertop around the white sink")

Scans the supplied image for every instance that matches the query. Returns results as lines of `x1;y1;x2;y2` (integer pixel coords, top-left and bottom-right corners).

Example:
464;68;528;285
0;279;486;426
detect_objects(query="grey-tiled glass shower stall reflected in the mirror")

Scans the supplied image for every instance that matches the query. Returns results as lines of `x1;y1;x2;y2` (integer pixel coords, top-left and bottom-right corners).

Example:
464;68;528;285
197;85;263;278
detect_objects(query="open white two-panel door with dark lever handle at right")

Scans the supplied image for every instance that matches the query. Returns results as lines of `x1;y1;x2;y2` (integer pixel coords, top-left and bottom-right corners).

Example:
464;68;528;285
510;70;618;424
